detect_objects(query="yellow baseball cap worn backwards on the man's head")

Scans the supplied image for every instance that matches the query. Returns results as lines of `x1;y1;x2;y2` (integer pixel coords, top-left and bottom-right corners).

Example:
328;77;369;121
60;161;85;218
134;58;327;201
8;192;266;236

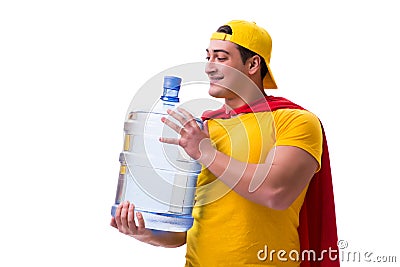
211;20;278;89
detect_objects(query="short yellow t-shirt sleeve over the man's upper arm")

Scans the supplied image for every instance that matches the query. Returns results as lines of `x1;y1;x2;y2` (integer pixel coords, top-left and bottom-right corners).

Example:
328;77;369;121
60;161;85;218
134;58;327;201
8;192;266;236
275;109;323;170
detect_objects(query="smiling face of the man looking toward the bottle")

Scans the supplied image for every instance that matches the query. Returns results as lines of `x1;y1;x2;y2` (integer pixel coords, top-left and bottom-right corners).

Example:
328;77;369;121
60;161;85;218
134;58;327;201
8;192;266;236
205;40;247;98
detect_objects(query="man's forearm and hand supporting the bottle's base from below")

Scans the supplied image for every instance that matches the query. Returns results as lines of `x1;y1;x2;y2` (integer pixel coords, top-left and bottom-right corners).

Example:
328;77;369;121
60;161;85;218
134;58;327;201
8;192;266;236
110;201;186;248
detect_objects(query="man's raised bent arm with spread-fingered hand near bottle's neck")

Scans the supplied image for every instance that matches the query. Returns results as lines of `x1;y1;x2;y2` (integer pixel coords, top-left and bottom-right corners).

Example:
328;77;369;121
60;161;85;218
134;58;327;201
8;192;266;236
160;109;318;210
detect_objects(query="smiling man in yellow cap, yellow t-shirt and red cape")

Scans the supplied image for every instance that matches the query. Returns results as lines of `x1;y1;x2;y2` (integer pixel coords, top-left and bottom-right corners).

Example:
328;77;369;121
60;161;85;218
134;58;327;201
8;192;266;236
111;21;338;266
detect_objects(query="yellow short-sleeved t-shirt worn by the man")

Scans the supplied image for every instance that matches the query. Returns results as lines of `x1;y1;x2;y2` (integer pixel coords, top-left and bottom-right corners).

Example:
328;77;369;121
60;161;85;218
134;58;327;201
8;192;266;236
186;109;322;267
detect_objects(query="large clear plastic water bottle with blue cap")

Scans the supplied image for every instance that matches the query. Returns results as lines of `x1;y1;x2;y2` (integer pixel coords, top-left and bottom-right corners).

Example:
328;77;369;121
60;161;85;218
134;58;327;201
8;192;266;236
111;76;201;232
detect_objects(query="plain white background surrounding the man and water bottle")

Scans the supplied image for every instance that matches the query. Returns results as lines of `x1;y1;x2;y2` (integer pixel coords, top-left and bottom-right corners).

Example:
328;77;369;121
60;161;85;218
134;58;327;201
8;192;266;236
0;0;400;266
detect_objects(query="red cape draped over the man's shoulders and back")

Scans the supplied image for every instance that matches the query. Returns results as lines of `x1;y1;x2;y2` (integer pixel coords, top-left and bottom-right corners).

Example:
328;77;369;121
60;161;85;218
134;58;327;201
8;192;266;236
202;96;340;267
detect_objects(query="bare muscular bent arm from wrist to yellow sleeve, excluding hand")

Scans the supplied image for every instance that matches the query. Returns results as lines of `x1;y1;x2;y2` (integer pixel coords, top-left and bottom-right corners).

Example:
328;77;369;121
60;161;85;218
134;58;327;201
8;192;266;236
199;146;318;210
